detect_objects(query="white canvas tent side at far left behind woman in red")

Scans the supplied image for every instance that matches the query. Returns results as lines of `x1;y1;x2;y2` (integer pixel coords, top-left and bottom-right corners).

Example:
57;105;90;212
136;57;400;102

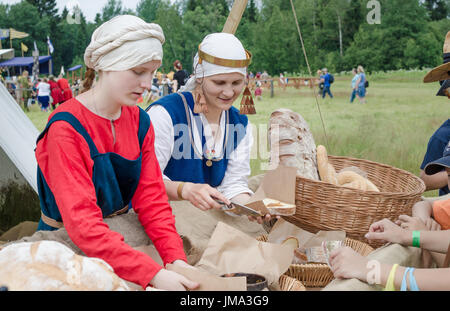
0;83;39;193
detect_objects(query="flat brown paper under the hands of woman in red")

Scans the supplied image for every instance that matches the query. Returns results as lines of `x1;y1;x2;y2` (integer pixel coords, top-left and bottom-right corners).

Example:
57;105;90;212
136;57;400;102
166;264;247;291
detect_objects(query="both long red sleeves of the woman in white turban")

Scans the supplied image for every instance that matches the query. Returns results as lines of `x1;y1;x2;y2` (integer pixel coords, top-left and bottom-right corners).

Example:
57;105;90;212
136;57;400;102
36;118;184;288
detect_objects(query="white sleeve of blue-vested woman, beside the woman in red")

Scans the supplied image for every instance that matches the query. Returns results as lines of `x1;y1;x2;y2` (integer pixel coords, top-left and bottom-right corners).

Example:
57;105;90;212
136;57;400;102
147;105;174;180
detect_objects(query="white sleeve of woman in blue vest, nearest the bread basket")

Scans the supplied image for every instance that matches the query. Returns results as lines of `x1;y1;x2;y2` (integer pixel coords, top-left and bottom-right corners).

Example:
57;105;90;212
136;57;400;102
217;121;253;199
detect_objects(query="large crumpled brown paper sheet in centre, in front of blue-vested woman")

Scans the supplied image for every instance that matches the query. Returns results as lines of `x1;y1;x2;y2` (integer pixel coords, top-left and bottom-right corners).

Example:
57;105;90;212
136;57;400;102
196;222;294;285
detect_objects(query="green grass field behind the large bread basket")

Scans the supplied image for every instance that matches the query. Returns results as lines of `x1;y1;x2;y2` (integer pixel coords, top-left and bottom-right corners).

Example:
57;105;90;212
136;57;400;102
27;71;450;196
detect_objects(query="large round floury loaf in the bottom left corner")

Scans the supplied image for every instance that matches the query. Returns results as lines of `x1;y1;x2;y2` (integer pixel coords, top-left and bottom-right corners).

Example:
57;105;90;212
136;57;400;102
0;241;130;291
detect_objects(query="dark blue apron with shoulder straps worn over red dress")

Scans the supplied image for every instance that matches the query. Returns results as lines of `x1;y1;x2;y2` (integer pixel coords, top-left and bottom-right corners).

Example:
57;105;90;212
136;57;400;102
36;108;150;230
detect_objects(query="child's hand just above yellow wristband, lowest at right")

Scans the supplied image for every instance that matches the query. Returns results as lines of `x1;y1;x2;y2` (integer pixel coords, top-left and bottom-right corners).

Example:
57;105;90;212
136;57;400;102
329;247;368;282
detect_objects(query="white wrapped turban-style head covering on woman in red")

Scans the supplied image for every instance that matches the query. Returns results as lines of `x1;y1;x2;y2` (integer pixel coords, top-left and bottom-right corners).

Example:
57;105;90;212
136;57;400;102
84;15;165;71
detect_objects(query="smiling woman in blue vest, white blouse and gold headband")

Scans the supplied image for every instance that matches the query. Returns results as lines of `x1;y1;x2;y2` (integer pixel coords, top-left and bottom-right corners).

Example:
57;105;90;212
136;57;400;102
147;33;270;244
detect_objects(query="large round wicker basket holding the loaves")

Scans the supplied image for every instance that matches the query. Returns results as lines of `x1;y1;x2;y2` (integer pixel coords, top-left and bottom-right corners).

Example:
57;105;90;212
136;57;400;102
284;156;425;247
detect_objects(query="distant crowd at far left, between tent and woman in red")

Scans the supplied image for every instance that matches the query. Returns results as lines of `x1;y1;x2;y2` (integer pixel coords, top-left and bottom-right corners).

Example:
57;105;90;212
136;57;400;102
0;70;73;112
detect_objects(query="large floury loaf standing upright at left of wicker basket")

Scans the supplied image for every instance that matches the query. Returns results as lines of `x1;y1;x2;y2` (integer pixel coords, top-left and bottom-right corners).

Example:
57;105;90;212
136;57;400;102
268;108;319;180
